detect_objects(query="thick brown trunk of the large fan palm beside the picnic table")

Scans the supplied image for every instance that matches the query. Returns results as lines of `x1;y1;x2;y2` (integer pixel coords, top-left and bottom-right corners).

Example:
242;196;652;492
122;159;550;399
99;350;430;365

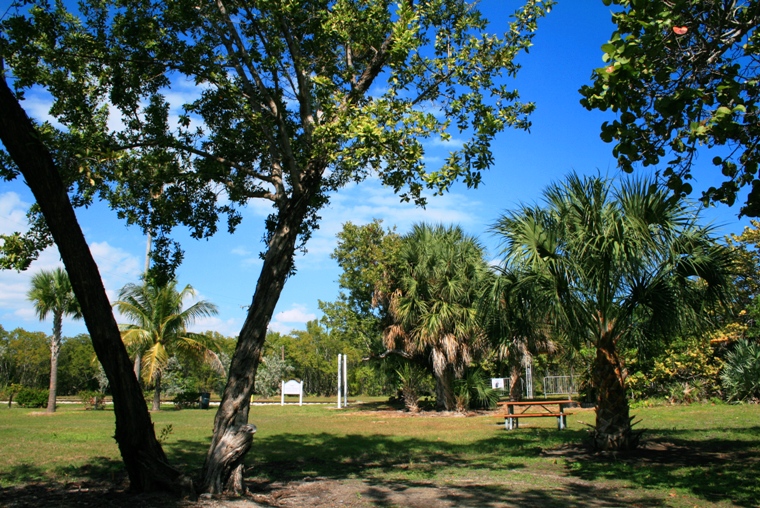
591;333;639;451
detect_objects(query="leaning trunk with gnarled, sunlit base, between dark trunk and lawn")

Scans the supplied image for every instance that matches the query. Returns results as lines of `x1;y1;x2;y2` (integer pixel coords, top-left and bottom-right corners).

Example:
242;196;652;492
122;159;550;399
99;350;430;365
202;187;319;494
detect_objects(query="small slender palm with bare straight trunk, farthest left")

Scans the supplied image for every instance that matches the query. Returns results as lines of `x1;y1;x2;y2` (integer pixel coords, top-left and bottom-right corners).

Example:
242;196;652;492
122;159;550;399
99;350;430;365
27;268;82;413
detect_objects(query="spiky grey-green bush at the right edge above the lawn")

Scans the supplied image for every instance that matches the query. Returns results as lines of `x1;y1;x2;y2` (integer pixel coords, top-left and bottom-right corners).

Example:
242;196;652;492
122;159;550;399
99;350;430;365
720;340;760;401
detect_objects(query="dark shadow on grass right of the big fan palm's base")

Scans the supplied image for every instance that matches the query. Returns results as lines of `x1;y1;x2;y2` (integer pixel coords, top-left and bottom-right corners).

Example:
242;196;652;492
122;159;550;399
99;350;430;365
566;427;760;506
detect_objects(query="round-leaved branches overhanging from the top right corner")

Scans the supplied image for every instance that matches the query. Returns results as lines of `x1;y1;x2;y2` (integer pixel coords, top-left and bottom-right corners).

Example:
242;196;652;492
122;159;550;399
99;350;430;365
581;0;760;217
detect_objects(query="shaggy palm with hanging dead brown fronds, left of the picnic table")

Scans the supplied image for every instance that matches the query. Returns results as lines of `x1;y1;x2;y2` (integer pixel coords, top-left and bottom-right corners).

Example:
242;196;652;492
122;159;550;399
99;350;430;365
384;224;487;411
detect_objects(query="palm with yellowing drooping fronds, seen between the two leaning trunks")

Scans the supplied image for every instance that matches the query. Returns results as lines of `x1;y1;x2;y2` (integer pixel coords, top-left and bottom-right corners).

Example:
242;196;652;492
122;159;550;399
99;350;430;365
114;280;221;411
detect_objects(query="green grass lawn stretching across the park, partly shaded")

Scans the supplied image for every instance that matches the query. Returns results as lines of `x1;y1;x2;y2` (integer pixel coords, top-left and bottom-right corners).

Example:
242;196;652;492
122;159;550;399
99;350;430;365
0;403;760;507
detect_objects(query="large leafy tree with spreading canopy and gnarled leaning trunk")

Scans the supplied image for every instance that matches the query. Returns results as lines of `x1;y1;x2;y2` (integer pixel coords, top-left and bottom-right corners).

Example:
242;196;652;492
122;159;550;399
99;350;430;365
0;0;550;492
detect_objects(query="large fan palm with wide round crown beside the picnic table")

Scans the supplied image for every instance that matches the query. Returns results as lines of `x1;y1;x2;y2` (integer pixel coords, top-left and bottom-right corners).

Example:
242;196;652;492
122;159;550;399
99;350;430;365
494;174;730;450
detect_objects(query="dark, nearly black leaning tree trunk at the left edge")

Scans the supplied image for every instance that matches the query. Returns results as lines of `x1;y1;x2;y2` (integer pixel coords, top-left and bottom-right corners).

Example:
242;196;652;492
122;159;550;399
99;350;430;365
0;72;192;493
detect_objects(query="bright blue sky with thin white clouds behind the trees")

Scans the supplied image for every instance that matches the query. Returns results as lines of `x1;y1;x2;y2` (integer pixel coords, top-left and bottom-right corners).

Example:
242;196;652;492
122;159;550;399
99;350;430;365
0;0;749;336
